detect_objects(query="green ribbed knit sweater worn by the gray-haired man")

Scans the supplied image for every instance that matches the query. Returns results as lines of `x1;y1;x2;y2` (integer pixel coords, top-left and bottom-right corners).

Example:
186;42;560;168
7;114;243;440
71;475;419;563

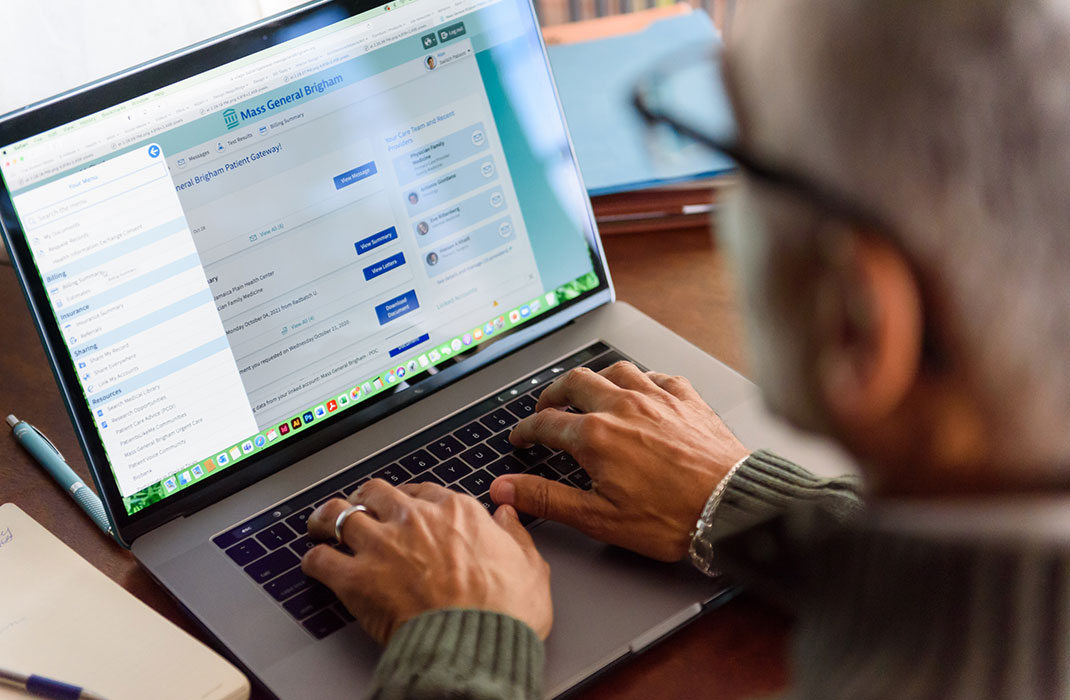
363;452;1070;700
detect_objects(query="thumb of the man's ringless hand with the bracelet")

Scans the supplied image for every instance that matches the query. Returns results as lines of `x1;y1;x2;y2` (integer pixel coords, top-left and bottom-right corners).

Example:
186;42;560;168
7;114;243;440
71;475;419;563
490;474;602;534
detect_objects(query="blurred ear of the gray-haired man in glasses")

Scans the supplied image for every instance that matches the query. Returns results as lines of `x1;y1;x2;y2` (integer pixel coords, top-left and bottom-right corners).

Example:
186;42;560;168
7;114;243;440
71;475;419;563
814;224;924;429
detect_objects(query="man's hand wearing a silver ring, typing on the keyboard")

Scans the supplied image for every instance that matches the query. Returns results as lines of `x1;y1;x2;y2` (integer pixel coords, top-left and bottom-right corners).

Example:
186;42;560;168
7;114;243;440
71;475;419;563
302;480;553;644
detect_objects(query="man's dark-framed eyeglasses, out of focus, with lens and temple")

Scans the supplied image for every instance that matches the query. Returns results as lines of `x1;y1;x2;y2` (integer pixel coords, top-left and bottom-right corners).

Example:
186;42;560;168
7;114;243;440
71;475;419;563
632;44;891;232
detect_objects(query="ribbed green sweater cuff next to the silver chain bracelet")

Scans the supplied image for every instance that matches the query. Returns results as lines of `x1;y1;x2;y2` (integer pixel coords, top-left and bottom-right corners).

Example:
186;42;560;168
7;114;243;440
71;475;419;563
710;450;863;542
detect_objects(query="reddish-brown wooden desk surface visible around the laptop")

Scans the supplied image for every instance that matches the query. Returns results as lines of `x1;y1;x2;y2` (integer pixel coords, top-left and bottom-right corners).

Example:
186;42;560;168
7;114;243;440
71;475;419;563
0;231;789;700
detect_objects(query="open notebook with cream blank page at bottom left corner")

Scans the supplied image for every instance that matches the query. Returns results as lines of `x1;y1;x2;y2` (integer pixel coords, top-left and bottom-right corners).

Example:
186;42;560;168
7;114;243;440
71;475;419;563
0;503;249;700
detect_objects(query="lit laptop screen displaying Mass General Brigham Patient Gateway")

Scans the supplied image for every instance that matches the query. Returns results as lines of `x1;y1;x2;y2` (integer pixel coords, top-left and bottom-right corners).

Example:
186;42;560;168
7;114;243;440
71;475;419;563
0;0;605;524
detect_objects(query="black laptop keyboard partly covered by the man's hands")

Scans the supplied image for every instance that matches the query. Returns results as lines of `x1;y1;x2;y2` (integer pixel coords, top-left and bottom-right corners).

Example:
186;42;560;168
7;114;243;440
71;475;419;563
212;343;625;639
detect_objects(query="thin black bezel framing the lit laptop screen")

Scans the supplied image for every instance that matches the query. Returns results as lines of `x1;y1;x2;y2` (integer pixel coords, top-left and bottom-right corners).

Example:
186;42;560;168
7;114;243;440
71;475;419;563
0;0;614;546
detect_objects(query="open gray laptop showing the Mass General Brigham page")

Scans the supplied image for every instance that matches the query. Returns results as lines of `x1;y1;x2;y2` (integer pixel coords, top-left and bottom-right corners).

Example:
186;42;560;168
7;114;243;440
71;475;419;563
0;0;851;698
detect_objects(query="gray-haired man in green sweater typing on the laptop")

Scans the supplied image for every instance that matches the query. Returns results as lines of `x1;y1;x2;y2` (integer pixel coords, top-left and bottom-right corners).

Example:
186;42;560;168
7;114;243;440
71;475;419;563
304;0;1070;700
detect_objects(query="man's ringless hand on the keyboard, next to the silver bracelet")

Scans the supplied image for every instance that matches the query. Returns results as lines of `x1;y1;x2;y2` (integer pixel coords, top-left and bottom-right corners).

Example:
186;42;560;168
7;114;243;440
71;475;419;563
490;362;749;561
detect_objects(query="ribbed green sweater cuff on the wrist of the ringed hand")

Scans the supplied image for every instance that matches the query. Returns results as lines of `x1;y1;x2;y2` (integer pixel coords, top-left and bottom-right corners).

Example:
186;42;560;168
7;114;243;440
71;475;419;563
369;609;544;700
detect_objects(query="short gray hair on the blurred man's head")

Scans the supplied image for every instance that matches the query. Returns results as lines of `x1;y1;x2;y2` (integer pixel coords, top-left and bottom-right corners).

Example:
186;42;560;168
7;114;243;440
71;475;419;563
737;0;1070;458
